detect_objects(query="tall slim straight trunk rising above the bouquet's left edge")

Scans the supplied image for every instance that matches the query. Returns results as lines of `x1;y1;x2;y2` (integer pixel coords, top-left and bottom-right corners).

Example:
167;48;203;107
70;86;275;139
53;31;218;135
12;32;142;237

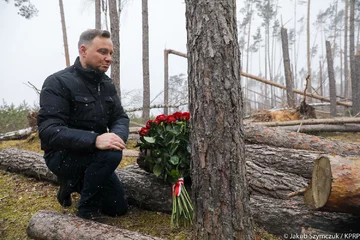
142;0;150;123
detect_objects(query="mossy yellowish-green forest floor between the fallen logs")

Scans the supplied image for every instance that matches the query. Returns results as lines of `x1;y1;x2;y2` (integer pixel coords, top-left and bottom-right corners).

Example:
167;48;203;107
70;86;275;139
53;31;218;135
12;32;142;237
0;136;278;240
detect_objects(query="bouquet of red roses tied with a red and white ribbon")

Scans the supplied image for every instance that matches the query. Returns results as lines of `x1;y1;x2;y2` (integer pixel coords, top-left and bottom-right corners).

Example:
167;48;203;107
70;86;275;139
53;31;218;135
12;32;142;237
137;112;193;227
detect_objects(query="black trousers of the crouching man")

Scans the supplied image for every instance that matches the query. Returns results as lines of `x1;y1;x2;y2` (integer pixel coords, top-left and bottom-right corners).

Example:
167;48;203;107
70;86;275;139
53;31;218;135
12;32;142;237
45;150;128;216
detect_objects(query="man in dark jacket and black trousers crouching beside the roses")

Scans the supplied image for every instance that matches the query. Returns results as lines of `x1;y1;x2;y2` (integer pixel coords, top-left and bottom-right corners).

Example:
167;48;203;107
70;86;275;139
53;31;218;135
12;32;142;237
38;29;129;220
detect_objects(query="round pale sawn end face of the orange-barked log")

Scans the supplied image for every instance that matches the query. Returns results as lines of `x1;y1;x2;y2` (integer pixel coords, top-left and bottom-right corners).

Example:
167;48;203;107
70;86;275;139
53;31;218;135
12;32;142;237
311;156;331;209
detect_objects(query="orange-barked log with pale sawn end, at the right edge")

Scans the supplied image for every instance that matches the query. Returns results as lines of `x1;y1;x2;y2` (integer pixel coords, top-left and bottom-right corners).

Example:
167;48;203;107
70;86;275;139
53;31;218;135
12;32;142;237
305;155;360;215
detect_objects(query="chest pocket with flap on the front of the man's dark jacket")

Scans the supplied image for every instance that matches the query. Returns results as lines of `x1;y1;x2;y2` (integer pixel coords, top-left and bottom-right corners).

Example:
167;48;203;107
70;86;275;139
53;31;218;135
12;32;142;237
73;96;96;121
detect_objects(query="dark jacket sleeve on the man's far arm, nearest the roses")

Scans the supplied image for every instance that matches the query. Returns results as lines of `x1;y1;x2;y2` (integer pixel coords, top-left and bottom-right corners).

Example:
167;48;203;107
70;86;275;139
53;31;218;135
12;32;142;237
108;95;130;142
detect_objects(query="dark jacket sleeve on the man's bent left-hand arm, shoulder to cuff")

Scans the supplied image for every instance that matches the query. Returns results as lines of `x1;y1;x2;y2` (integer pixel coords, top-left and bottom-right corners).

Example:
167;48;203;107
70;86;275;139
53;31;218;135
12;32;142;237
38;75;98;150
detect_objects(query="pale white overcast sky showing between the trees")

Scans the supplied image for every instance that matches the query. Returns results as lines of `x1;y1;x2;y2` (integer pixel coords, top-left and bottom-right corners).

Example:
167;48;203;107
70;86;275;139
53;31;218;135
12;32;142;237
0;0;331;105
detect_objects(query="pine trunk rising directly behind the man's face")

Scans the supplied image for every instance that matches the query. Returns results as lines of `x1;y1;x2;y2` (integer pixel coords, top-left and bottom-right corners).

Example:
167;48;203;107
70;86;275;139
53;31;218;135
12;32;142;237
109;0;121;98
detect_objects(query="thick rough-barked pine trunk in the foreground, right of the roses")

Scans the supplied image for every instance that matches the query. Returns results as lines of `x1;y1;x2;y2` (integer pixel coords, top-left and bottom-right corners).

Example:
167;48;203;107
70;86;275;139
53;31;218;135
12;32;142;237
185;0;254;239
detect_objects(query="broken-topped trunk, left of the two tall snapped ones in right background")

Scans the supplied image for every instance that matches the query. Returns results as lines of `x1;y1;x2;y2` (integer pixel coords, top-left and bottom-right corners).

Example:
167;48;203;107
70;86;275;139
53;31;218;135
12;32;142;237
281;27;295;108
